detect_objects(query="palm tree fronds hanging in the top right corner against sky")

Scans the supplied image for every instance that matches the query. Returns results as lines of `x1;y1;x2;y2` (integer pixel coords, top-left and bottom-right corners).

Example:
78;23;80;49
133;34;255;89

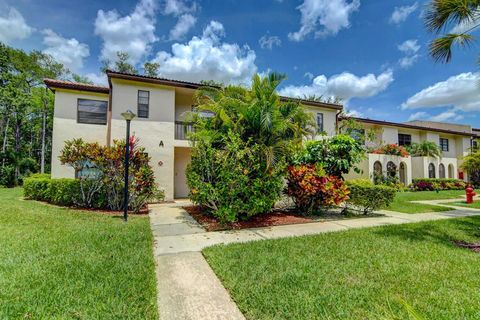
425;0;480;63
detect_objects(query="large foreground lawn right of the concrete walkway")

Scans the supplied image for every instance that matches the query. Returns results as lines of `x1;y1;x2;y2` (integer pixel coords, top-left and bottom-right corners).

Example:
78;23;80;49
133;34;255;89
203;217;480;320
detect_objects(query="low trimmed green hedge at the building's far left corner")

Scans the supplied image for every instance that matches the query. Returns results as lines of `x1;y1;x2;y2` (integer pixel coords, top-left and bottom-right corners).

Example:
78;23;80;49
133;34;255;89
23;176;80;206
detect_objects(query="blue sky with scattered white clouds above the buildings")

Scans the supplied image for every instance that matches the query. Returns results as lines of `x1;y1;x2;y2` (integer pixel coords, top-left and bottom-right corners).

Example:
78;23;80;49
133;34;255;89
0;0;480;127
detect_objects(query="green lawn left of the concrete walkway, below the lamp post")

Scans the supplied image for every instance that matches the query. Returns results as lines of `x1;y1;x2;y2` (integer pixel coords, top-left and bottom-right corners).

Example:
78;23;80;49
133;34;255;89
0;188;158;319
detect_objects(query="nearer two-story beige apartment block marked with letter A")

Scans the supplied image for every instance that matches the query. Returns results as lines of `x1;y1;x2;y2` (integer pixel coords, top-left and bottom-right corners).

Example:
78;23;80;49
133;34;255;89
45;71;342;199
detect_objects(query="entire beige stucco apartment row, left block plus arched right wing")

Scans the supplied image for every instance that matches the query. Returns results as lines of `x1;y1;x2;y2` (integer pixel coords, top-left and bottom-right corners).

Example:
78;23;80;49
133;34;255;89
45;71;480;199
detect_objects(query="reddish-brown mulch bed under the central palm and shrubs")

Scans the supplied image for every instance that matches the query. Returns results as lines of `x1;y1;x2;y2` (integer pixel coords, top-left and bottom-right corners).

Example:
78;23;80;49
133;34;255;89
183;206;319;231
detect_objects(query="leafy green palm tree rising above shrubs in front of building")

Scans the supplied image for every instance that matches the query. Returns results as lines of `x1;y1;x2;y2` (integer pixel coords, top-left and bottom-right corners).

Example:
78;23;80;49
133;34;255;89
188;73;315;168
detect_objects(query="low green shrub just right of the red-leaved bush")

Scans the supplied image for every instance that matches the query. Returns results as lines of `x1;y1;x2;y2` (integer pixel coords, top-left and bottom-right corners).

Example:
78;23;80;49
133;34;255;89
347;182;396;214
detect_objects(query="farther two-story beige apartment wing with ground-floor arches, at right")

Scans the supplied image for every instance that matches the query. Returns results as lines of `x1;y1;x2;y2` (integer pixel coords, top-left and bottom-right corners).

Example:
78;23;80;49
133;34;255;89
347;118;477;185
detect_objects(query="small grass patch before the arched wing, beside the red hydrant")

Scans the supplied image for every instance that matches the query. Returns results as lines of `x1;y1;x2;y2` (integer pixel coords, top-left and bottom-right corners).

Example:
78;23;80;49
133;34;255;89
387;190;465;213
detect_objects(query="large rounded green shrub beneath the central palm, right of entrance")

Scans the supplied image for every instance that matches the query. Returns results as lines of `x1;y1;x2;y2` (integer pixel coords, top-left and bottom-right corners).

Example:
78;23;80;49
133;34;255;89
187;134;283;223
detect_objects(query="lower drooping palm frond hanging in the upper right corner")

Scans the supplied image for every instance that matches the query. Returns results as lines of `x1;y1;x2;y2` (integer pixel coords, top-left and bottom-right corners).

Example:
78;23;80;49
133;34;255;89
429;33;474;63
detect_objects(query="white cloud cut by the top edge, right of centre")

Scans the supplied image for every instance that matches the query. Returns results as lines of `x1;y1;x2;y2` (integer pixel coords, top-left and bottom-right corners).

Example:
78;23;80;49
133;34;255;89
288;0;360;41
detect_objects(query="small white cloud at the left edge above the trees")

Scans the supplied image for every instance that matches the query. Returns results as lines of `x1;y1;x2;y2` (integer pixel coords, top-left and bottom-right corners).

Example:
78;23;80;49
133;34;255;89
0;6;34;43
